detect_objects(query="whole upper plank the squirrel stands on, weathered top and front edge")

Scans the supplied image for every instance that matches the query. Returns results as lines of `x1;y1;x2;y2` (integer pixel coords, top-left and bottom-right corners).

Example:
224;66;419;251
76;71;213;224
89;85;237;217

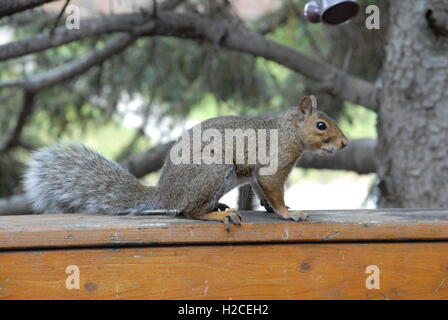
0;209;448;249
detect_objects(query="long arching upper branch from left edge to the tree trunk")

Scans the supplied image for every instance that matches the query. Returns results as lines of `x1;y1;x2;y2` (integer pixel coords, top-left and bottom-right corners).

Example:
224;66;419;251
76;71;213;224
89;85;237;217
0;11;380;111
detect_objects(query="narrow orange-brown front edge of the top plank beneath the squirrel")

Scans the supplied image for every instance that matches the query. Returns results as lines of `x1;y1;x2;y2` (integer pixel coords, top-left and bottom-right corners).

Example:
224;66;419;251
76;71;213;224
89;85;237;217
0;221;448;250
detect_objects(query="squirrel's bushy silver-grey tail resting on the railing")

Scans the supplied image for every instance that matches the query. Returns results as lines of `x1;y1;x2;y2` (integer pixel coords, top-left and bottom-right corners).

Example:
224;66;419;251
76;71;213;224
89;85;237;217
24;144;156;214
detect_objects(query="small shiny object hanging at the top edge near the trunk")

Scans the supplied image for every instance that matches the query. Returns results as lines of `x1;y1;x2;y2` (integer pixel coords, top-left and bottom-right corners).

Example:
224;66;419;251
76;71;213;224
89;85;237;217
304;0;360;25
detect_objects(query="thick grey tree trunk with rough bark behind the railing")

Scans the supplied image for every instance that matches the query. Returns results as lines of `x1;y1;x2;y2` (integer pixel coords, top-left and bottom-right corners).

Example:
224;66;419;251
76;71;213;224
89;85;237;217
378;0;448;208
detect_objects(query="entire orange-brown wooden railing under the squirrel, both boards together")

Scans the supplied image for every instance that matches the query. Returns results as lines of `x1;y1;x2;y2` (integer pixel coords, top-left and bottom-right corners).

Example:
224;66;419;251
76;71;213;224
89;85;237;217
0;209;448;299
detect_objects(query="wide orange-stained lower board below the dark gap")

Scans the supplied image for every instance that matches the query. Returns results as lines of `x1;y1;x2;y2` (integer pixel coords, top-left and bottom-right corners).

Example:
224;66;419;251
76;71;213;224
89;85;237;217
0;242;448;299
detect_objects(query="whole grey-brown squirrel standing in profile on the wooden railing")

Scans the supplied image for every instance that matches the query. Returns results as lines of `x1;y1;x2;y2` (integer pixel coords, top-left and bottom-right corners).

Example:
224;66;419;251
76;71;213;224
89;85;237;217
24;96;348;230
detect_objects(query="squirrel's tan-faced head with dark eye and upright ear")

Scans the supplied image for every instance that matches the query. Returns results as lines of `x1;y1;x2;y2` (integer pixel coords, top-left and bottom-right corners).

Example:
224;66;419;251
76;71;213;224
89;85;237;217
298;96;348;155
